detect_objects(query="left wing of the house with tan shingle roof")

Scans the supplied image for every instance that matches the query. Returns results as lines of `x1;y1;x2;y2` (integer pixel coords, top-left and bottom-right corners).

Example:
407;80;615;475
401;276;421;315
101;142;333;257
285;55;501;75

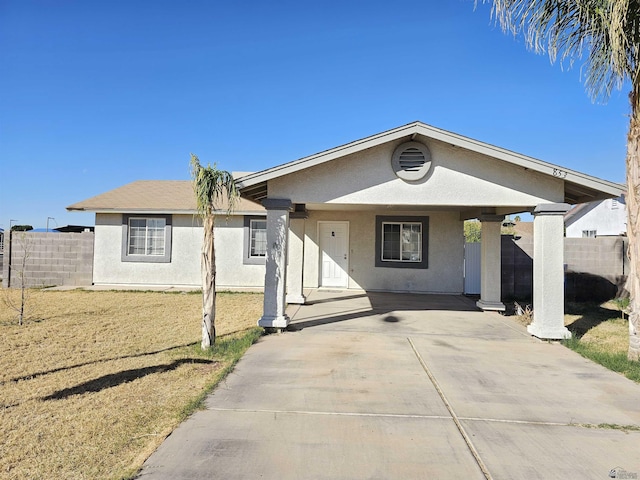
67;180;266;290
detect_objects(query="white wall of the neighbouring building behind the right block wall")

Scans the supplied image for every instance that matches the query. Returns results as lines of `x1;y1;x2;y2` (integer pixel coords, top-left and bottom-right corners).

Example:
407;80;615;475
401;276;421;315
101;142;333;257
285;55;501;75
566;198;627;238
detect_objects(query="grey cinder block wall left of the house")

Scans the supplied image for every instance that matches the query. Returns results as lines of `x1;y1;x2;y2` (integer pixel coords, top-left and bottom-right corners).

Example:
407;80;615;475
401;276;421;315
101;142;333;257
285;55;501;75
2;232;94;288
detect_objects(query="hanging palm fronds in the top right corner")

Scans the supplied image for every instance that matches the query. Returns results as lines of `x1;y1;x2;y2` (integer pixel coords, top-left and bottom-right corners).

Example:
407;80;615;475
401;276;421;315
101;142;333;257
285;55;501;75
483;0;640;104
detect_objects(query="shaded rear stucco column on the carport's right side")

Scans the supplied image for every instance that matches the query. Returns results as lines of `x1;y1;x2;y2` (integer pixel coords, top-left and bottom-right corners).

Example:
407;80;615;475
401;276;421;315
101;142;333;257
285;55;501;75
476;215;505;311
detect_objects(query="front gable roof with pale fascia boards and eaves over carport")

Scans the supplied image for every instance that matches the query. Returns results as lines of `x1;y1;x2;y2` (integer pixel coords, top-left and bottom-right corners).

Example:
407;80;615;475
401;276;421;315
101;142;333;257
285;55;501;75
238;122;624;204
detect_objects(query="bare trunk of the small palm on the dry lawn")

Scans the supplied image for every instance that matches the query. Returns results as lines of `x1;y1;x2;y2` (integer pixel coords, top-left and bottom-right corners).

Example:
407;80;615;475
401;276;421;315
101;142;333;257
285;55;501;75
200;215;216;350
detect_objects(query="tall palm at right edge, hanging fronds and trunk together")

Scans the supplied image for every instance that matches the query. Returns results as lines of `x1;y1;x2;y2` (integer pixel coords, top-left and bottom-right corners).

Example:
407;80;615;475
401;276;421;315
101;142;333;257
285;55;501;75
483;0;640;360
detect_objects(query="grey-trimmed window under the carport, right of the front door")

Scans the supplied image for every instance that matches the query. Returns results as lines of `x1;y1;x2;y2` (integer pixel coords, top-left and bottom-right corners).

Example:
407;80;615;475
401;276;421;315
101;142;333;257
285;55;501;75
375;216;429;268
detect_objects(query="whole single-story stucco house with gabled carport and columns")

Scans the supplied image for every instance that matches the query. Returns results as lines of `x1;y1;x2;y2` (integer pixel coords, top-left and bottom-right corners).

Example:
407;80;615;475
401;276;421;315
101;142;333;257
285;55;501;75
68;122;623;338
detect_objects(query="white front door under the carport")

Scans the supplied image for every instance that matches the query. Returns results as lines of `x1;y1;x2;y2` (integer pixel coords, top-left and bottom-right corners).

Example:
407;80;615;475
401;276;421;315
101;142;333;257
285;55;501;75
318;222;349;288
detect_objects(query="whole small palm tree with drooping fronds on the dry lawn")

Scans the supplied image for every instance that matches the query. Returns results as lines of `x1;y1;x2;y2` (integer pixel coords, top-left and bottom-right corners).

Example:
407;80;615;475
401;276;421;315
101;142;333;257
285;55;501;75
191;153;239;350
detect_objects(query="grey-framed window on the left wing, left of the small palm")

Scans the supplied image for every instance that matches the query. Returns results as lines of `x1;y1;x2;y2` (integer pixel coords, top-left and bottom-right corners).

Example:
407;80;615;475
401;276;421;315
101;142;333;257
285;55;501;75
122;215;172;263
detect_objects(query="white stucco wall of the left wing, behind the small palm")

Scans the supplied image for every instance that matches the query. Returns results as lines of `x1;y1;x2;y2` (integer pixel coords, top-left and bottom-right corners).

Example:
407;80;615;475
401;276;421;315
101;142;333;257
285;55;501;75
93;213;264;290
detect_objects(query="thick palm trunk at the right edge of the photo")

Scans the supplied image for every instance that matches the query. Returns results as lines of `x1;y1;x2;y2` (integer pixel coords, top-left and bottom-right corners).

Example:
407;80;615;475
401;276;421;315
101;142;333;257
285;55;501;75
627;86;640;360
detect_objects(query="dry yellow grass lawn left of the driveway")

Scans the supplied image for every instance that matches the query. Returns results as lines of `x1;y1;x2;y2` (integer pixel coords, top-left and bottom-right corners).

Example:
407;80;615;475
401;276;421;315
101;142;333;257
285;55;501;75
0;290;262;480
